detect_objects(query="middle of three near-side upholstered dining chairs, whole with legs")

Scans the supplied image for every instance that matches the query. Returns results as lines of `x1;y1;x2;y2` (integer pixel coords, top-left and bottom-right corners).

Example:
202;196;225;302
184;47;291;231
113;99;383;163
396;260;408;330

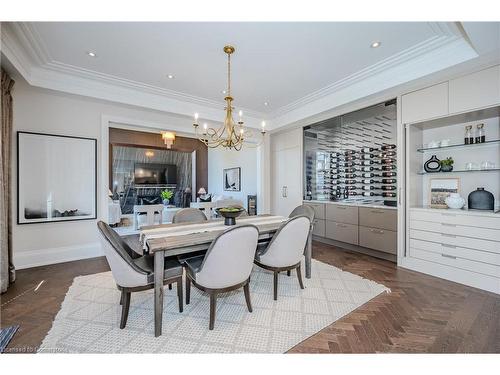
185;225;259;330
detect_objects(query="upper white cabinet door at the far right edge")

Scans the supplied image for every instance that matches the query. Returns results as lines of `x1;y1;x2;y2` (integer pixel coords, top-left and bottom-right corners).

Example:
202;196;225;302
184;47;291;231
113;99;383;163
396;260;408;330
449;65;500;114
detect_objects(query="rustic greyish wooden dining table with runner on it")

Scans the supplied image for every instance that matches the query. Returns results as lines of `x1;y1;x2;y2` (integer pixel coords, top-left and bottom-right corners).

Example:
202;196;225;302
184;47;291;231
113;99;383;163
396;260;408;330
140;215;312;337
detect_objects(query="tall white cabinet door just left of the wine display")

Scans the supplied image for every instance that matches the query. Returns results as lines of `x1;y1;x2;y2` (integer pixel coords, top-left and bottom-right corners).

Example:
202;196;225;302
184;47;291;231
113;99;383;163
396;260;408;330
271;129;302;216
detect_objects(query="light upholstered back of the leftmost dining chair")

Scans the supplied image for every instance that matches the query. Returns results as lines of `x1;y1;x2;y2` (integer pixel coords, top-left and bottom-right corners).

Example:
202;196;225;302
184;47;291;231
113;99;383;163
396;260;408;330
97;221;148;287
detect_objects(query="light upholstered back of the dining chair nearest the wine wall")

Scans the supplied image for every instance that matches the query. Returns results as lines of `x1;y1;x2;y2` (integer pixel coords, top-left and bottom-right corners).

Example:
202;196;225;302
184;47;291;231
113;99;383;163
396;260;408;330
259;215;311;267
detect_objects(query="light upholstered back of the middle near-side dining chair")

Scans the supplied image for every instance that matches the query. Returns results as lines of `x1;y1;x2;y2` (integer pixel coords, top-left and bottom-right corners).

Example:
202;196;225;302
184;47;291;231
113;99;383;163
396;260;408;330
196;225;259;289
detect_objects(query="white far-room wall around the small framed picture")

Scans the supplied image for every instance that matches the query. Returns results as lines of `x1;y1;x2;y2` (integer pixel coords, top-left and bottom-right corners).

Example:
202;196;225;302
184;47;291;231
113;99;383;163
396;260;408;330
208;146;260;212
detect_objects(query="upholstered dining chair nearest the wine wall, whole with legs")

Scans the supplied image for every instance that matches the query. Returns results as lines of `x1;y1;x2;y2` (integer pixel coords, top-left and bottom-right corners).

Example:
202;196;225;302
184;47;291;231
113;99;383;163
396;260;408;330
254;215;311;301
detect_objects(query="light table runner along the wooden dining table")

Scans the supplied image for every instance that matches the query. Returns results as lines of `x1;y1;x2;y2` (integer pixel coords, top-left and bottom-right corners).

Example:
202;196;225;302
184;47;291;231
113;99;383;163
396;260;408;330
140;216;288;246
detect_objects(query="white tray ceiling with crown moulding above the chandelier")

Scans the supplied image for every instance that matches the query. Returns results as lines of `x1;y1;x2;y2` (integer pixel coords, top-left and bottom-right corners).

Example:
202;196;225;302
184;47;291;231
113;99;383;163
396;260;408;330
2;22;496;131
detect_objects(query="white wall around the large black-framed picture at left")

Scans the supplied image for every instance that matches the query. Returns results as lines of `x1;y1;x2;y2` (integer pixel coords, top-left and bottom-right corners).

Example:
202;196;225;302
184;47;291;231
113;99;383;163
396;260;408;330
12;79;203;268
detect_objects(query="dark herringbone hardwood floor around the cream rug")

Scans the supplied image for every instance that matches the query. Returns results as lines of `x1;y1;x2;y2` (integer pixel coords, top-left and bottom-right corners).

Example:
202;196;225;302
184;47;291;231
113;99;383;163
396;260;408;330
0;242;500;353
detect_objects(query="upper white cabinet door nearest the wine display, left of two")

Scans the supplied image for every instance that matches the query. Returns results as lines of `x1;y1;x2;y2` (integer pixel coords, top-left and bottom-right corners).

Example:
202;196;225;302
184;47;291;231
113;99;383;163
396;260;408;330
401;82;448;124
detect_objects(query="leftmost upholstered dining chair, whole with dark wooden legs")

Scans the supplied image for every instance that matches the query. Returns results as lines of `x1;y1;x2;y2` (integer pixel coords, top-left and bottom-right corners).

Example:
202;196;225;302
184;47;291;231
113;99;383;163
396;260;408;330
97;221;183;329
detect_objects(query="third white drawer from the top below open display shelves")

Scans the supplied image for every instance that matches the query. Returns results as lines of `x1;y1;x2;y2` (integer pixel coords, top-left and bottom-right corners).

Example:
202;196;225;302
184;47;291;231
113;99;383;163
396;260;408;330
410;238;500;266
